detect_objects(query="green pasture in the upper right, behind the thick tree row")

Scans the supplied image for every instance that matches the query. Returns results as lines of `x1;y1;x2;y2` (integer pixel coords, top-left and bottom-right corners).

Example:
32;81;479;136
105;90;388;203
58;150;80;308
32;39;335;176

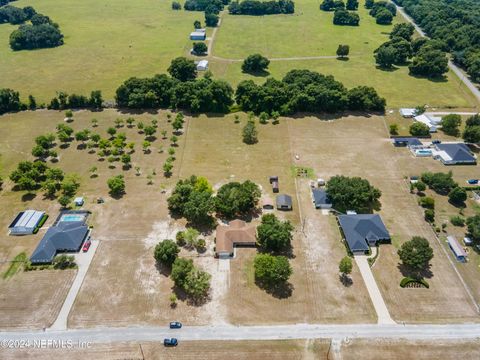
210;0;478;108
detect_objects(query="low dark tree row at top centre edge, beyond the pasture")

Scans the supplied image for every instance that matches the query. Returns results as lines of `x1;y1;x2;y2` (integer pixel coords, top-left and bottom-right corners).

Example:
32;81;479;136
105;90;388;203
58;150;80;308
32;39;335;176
228;0;295;15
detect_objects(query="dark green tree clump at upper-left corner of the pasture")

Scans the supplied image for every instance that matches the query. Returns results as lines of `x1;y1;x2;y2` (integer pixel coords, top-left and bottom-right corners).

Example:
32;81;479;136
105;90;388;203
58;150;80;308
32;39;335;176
0;5;63;51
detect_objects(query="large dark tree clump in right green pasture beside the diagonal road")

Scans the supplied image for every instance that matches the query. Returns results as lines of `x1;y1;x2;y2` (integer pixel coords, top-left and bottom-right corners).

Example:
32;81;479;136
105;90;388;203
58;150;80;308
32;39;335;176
374;23;448;78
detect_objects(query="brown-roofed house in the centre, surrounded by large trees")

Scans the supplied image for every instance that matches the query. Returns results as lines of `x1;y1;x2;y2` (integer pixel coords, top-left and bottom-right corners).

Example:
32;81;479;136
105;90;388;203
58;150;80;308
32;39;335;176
215;219;257;258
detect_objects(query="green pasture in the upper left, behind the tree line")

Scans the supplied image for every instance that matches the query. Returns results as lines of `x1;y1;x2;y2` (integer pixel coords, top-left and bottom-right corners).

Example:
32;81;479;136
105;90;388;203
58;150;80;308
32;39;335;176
0;0;199;101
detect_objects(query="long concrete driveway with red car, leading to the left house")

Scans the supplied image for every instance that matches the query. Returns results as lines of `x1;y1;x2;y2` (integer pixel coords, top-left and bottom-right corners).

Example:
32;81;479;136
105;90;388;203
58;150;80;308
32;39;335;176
46;240;99;331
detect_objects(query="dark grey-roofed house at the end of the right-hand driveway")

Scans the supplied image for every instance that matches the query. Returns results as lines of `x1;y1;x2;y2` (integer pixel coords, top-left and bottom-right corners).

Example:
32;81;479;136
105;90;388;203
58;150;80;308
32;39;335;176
338;214;390;254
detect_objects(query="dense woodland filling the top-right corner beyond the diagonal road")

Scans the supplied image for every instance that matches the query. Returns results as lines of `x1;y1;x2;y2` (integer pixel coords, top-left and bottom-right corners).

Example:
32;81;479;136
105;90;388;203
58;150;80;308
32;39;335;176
395;0;480;81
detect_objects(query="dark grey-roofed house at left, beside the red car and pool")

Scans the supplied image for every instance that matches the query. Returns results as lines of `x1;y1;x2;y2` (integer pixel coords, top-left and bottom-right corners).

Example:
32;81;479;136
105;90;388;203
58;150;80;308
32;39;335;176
30;221;89;264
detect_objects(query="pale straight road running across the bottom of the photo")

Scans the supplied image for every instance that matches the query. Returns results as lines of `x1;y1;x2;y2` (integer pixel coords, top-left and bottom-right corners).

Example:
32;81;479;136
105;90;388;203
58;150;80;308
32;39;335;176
0;323;480;344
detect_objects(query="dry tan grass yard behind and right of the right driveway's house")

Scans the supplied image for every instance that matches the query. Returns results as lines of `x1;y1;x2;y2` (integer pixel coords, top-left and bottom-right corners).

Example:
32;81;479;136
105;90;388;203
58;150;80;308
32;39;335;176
290;116;476;322
